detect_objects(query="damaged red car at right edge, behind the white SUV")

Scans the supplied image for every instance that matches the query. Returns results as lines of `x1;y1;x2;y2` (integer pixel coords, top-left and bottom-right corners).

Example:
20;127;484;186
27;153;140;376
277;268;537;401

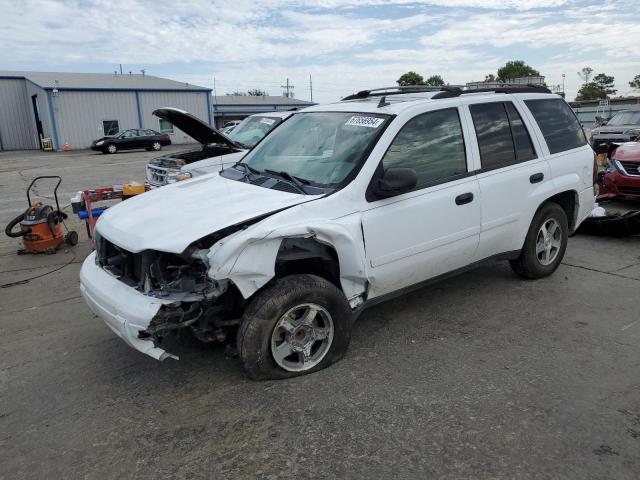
598;142;640;200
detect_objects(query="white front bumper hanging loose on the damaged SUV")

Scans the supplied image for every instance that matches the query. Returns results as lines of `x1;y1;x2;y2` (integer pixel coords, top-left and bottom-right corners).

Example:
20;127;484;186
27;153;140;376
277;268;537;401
80;252;177;360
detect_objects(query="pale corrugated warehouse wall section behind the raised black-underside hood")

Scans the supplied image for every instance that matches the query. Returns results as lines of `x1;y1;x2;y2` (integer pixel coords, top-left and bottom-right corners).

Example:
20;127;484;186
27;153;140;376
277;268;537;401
138;92;209;144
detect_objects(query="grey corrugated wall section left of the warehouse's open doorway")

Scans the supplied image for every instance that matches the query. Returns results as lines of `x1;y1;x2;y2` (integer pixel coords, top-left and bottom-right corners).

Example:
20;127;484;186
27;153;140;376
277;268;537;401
0;78;38;150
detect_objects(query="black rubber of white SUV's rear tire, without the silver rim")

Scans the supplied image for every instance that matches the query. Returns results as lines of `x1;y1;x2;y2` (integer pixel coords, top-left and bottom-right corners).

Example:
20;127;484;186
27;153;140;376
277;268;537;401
509;202;569;279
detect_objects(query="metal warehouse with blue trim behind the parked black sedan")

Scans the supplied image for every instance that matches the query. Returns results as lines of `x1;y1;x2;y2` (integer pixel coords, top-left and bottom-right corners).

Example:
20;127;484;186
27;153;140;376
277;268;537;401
0;71;212;150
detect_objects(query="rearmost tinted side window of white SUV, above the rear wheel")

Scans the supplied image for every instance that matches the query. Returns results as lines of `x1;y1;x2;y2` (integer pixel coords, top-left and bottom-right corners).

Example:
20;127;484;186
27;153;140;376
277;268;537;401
524;98;587;153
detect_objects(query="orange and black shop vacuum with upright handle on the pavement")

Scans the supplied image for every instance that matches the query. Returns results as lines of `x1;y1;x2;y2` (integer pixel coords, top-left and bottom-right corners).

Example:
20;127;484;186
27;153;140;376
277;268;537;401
4;175;78;255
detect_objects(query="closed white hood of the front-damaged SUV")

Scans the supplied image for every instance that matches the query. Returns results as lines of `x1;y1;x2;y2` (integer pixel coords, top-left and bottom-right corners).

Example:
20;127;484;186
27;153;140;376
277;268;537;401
97;173;322;253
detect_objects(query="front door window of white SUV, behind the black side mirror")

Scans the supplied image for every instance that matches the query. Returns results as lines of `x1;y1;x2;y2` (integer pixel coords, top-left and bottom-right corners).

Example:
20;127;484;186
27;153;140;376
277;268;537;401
382;108;467;189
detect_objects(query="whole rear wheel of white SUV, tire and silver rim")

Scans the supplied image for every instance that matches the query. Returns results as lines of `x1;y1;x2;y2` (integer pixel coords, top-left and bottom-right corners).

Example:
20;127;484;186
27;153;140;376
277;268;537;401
509;202;569;279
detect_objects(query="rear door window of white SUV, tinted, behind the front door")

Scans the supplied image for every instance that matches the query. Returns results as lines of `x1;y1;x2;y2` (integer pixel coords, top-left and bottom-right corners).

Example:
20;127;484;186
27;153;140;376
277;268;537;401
469;102;536;170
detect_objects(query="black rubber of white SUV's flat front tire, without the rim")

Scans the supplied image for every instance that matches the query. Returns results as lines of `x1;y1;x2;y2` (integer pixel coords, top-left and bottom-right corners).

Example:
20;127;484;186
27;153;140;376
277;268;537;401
237;275;355;380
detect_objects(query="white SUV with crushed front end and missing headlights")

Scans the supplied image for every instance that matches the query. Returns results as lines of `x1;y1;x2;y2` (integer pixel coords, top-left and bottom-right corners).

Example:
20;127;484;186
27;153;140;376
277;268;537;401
80;87;594;378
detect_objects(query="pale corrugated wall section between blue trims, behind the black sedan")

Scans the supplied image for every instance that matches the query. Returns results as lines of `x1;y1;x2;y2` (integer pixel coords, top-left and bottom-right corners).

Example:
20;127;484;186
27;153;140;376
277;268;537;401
51;90;138;149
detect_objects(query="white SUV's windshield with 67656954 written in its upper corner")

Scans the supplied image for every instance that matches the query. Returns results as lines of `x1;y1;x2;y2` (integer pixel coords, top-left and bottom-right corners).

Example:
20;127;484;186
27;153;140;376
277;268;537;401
243;112;389;186
